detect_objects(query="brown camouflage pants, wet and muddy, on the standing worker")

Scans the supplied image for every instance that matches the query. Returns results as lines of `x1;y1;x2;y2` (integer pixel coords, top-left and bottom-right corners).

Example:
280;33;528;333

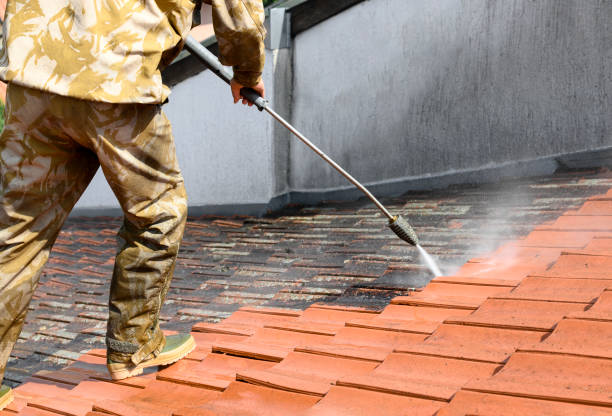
0;85;187;381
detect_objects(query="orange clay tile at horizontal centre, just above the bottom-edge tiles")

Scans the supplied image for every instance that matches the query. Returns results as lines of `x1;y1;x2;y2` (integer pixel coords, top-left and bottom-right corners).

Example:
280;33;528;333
236;352;378;396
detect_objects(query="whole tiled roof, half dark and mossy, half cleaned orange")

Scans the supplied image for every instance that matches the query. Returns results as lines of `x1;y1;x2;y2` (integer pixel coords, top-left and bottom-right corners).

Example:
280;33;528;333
4;167;612;416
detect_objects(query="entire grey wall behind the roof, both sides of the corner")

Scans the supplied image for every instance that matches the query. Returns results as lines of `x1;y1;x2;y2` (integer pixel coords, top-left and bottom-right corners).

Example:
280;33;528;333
78;0;612;213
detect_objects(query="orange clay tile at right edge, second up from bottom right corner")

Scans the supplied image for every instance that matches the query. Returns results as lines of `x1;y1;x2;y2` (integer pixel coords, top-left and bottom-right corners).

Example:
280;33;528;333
464;352;612;407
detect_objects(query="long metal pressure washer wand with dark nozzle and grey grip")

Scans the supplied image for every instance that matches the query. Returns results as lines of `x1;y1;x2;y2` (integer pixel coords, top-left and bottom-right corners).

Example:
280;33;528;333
185;36;419;246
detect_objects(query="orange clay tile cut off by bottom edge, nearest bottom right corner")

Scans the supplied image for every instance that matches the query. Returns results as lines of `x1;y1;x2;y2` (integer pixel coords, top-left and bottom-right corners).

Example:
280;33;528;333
436;390;611;416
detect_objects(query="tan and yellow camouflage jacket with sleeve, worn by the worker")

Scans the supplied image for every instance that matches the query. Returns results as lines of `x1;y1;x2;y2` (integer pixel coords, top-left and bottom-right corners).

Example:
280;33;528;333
0;0;265;104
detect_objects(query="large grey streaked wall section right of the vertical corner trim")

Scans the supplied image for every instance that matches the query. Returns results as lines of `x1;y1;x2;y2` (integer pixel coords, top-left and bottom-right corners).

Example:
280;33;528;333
290;0;612;191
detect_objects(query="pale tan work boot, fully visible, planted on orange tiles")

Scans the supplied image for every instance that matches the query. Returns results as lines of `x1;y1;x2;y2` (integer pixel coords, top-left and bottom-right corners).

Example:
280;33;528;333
106;334;195;380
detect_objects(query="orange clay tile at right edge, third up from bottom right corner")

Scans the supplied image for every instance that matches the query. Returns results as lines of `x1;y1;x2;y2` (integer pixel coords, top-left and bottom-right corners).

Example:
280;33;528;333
521;319;612;359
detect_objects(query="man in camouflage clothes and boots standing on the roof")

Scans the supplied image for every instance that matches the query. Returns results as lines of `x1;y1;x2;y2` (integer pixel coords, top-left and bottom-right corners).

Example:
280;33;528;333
0;0;265;409
